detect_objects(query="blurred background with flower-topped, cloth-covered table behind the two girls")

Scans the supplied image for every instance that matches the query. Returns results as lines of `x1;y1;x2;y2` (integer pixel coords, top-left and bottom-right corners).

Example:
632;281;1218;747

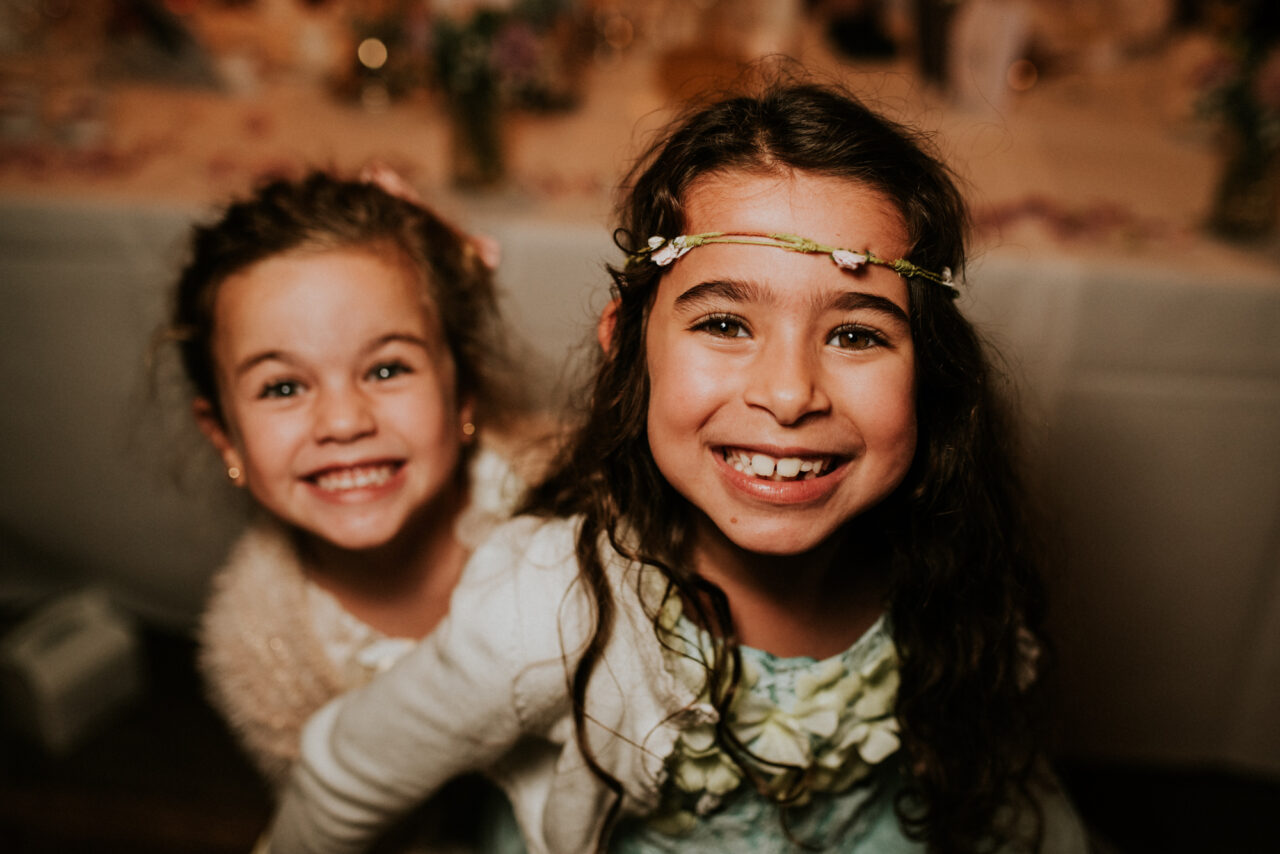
0;0;1280;853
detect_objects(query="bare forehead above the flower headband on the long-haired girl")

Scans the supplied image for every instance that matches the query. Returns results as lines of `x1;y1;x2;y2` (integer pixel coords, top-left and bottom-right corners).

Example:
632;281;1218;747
684;170;910;257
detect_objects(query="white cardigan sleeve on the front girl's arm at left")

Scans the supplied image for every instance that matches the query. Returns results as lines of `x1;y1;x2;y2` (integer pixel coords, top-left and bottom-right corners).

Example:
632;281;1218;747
270;519;586;854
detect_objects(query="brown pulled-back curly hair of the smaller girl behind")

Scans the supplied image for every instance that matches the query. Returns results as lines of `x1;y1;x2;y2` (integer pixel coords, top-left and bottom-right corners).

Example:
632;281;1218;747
164;172;513;430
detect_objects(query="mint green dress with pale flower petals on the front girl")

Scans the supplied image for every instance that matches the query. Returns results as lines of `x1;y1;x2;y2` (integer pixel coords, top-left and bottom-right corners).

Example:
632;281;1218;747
609;616;1088;854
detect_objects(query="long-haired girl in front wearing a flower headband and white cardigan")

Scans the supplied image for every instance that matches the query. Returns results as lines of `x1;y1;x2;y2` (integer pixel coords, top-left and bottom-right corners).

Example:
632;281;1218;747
264;86;1085;854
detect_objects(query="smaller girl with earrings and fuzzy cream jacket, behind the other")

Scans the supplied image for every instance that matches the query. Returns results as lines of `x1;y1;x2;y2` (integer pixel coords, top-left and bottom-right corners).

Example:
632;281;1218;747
168;166;540;850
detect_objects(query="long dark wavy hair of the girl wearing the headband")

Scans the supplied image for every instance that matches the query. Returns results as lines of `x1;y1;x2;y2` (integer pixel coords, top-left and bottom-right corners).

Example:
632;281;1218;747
527;83;1043;853
